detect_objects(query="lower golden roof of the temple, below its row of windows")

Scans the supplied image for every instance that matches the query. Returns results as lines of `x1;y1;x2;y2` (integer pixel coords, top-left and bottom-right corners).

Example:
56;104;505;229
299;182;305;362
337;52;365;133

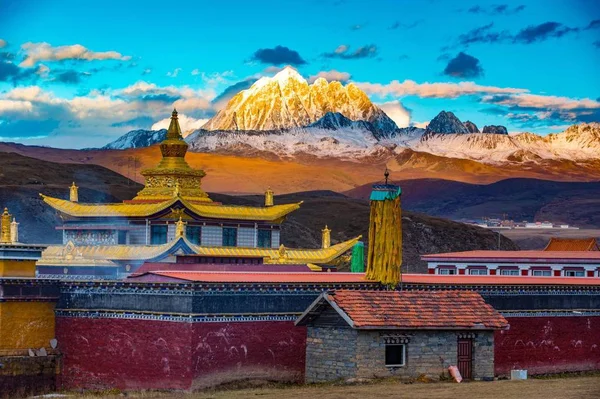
38;236;361;265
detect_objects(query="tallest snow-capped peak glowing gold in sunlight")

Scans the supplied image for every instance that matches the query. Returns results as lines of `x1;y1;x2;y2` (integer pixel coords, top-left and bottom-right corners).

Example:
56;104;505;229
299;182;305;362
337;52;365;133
202;67;398;138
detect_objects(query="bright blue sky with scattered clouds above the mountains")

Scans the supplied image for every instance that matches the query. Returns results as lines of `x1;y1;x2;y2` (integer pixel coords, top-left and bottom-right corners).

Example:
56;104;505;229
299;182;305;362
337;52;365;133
0;0;600;147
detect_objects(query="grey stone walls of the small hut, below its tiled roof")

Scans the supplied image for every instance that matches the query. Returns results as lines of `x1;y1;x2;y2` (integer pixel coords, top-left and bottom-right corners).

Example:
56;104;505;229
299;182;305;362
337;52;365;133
306;327;494;383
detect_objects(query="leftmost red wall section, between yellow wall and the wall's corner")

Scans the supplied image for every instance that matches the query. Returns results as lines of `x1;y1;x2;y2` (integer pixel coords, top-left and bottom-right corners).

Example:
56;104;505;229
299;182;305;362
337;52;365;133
56;317;192;389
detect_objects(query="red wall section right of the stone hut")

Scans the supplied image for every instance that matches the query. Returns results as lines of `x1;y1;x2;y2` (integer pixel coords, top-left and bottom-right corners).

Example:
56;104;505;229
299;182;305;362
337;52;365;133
494;316;600;375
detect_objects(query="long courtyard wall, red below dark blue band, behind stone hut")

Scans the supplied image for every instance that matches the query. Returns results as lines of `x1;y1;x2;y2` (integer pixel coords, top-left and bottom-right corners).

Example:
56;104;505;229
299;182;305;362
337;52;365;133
0;280;600;389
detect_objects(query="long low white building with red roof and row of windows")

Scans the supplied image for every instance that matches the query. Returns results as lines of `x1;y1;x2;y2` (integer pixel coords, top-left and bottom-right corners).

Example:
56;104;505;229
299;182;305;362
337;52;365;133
421;250;600;277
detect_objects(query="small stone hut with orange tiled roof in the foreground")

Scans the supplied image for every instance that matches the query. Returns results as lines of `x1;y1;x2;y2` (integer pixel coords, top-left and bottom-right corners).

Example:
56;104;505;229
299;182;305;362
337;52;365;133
296;290;508;383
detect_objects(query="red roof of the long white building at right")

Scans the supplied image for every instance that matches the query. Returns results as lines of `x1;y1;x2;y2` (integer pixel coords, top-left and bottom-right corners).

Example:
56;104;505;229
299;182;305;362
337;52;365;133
421;251;600;262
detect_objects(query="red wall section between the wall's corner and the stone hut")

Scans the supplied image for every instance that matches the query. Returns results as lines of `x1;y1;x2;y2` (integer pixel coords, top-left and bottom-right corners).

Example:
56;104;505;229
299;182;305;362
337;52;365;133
192;321;306;388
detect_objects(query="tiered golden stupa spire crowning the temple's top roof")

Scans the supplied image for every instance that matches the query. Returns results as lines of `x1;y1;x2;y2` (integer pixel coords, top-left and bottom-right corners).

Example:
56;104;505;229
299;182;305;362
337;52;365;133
134;109;211;202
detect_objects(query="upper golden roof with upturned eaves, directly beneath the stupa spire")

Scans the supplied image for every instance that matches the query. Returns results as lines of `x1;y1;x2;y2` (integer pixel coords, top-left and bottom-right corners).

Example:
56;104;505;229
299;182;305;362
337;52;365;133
40;194;302;222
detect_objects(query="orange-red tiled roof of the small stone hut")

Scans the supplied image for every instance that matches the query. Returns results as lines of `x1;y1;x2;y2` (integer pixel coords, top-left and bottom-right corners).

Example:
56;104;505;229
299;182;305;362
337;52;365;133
298;290;508;330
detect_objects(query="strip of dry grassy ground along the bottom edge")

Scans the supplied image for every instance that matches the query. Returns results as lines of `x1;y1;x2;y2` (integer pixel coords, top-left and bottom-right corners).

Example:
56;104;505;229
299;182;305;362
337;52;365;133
65;375;600;399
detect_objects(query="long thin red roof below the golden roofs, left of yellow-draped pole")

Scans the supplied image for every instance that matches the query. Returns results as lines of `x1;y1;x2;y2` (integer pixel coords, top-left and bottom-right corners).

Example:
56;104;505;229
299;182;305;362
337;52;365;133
128;271;373;283
